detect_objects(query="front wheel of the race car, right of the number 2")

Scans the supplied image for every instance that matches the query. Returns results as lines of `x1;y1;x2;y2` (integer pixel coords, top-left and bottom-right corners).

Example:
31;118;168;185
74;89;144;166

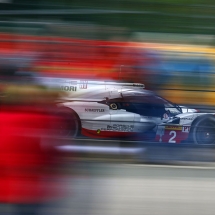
190;114;215;145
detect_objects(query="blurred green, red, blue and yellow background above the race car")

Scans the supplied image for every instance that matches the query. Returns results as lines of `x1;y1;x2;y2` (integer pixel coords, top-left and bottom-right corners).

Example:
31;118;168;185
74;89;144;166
0;0;215;106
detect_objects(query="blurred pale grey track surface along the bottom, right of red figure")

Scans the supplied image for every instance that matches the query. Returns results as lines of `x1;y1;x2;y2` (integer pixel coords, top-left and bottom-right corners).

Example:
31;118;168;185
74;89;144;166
50;162;215;215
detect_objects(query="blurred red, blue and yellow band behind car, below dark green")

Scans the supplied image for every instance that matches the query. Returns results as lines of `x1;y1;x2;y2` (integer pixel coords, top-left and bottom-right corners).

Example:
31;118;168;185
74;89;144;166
0;33;215;107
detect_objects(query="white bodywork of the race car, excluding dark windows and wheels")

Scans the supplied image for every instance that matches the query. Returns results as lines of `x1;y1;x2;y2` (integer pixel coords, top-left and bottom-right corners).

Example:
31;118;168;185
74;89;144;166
35;78;215;141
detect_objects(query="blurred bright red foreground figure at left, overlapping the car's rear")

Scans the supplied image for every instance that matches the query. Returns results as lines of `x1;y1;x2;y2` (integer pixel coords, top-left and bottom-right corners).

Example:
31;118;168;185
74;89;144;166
0;65;69;215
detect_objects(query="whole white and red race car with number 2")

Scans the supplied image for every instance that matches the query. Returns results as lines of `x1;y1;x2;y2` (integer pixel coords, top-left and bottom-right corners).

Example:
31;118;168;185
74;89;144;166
38;78;215;144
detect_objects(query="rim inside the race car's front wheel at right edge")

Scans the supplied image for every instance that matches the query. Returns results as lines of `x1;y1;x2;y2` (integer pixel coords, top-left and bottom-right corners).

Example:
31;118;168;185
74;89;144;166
196;122;215;144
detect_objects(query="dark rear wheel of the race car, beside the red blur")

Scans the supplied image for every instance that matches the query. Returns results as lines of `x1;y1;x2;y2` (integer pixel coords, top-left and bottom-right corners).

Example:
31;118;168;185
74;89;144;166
56;107;81;138
